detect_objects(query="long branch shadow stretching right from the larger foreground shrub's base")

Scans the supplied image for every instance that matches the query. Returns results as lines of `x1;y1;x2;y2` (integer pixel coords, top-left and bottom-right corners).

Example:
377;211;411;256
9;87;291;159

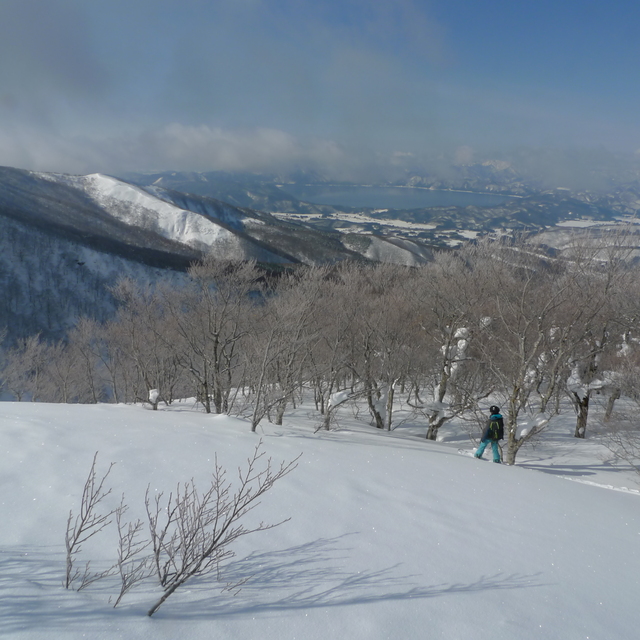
157;534;544;618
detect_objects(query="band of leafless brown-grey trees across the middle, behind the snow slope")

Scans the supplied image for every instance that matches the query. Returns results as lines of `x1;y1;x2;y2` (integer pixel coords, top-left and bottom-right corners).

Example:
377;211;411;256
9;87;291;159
0;232;640;463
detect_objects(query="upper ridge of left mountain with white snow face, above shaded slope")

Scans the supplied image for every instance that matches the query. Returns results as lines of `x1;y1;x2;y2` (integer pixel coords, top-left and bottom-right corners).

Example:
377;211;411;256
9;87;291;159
0;168;429;264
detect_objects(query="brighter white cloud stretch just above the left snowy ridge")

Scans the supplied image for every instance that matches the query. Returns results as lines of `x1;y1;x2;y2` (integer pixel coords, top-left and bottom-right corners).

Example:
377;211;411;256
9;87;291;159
0;123;348;173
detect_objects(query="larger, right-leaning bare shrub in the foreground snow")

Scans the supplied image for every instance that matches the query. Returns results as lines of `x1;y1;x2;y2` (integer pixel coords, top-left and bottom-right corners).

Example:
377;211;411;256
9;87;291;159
146;443;297;616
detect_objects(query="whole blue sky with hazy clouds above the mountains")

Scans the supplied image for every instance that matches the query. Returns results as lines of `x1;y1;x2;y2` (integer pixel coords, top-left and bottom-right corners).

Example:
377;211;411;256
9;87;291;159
0;0;640;178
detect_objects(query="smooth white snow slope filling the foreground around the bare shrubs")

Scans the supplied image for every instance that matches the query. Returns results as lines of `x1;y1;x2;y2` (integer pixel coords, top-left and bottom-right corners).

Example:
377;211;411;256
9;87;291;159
0;402;640;640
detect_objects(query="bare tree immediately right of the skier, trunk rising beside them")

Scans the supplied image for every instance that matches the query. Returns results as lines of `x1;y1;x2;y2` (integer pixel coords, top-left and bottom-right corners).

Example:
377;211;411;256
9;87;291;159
473;239;572;464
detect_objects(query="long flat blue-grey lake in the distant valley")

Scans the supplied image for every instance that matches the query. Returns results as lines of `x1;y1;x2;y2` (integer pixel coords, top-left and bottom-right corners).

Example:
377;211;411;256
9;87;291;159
281;184;510;209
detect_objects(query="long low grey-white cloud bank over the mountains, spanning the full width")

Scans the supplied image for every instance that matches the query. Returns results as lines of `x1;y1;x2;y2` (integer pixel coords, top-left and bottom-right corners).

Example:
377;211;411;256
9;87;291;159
0;122;640;191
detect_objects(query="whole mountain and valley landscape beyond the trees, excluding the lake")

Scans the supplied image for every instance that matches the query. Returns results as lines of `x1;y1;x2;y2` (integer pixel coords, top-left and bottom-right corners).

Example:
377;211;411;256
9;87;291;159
0;162;640;339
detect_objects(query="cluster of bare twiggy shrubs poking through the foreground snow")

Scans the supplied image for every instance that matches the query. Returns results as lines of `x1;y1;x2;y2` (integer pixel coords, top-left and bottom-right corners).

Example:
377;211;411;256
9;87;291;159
64;442;297;616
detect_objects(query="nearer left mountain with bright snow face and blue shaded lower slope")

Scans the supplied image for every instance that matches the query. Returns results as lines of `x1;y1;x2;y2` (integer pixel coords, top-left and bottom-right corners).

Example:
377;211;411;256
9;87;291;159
0;167;431;339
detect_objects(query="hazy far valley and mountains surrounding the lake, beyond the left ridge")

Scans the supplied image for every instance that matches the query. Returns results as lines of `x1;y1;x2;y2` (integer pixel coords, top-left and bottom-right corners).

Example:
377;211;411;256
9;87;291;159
121;169;640;249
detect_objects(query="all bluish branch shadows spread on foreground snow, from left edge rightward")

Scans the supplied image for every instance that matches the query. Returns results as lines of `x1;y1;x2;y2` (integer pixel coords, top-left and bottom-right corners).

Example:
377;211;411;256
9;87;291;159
0;534;544;624
